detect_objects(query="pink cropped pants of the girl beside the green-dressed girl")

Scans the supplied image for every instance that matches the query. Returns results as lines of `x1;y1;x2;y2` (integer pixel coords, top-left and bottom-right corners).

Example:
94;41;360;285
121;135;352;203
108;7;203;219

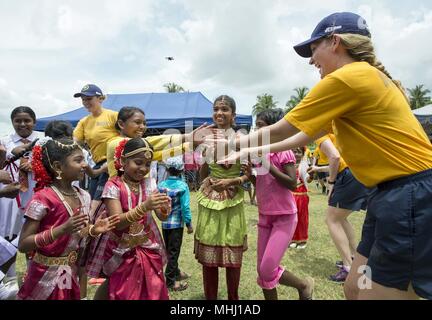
257;214;297;290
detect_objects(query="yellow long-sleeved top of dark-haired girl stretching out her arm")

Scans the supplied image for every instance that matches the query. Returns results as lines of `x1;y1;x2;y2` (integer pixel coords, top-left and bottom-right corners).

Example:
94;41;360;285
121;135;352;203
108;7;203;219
106;135;190;178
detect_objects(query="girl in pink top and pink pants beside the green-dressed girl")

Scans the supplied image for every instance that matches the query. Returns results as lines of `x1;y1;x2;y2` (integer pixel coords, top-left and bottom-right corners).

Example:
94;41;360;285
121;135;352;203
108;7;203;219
244;109;314;300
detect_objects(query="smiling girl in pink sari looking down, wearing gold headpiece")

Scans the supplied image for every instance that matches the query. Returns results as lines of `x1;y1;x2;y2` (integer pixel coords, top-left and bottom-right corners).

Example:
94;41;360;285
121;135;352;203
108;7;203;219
102;138;171;300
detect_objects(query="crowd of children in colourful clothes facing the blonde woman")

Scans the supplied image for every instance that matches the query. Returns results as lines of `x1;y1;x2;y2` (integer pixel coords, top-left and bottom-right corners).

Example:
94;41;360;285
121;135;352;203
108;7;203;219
0;95;320;300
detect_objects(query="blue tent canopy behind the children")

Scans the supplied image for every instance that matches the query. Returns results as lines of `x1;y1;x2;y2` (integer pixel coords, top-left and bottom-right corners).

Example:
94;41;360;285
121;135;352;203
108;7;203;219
35;92;252;131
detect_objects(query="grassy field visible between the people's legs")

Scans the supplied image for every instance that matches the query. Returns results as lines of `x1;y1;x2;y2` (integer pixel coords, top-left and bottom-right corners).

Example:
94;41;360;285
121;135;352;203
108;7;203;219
17;186;364;300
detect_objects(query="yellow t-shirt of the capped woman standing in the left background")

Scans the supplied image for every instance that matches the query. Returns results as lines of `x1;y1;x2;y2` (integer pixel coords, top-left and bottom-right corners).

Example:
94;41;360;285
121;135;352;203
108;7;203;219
74;108;118;163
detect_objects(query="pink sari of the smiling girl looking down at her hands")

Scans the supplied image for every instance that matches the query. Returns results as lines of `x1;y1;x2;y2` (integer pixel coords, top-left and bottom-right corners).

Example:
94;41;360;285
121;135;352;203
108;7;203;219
102;177;169;300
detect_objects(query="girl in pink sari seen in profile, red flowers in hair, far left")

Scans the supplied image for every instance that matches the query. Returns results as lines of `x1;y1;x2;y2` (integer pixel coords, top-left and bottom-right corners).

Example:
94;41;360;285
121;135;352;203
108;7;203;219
18;139;119;300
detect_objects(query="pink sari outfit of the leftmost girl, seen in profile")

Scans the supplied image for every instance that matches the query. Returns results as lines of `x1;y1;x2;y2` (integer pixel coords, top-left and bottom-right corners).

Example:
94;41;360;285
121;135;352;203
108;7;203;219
17;188;90;300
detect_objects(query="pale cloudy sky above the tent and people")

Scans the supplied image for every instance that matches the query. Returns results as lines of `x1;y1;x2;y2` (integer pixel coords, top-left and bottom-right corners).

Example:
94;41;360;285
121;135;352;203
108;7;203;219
0;0;432;135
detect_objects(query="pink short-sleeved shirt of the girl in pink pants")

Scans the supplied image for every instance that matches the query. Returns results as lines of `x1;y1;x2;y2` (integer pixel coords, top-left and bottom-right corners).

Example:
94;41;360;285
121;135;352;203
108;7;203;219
256;150;297;215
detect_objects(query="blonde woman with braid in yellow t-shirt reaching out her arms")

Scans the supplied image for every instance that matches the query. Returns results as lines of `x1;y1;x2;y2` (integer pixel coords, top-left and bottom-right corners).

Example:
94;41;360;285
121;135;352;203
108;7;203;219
222;12;432;299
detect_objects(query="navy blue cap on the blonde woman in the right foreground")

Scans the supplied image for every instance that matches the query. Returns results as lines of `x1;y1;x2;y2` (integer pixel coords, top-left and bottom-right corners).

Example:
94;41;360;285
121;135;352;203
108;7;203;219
294;12;371;58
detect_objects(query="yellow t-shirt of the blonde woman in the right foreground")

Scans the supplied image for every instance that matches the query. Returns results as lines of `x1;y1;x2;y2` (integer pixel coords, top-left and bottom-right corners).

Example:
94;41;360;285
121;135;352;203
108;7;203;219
285;62;432;187
